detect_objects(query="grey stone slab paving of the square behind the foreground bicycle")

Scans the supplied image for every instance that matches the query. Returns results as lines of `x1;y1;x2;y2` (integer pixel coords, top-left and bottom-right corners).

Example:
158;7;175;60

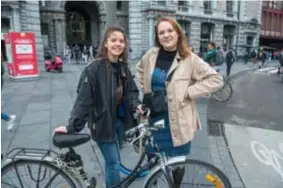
1;59;260;187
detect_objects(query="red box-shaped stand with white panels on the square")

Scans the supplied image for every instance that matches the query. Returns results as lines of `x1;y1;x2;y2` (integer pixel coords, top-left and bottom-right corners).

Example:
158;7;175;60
4;32;38;79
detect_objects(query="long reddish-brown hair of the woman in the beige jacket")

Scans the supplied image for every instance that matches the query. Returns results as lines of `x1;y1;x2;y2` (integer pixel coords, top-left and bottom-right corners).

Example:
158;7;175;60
155;17;191;59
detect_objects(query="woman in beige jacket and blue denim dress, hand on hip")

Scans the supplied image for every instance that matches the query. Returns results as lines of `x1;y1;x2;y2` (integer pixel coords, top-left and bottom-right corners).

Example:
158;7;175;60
137;17;223;187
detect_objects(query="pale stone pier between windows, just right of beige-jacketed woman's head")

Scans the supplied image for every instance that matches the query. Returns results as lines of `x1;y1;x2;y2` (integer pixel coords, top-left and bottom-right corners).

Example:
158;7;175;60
190;20;201;54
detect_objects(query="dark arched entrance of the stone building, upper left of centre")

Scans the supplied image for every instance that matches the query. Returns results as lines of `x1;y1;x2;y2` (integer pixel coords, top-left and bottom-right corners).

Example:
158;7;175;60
64;1;101;47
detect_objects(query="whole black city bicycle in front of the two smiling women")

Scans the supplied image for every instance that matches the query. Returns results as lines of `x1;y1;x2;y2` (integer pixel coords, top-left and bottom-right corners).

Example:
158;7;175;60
1;111;231;188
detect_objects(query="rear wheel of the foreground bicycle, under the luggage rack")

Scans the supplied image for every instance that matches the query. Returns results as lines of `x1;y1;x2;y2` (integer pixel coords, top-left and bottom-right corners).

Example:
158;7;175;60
1;160;76;188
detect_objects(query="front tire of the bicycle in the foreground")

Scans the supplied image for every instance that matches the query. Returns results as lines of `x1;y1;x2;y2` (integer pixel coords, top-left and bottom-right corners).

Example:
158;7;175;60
144;159;232;188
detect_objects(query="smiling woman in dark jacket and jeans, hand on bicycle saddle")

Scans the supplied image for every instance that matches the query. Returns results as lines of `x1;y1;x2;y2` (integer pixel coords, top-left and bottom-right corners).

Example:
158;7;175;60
55;26;140;188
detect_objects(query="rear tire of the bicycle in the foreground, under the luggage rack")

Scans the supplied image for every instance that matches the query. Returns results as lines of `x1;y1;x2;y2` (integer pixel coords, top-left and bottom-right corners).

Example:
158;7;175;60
1;159;76;188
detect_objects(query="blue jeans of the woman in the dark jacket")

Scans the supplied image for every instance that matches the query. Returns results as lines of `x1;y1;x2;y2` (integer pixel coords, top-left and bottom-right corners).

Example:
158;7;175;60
97;121;122;188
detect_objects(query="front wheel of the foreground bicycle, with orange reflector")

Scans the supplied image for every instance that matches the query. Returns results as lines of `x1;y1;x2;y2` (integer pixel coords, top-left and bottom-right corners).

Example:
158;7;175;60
144;159;231;188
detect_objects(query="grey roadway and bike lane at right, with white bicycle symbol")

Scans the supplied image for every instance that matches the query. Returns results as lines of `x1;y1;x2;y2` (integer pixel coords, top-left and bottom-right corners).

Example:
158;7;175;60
208;62;283;188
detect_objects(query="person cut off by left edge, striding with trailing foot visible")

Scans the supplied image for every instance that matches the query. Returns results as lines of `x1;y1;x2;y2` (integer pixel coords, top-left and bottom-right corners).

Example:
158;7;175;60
1;52;16;131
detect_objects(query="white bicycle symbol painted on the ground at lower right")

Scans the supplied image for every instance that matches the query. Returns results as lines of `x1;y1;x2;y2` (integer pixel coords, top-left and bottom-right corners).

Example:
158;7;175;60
251;140;283;181
